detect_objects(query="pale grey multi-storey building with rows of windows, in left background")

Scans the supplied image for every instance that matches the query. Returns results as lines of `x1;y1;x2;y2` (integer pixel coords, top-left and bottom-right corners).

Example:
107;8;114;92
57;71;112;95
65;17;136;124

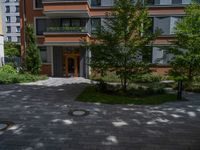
1;0;21;43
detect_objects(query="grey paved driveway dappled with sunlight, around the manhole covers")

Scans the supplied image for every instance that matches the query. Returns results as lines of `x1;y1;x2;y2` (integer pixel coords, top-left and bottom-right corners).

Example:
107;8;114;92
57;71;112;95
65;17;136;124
0;78;200;150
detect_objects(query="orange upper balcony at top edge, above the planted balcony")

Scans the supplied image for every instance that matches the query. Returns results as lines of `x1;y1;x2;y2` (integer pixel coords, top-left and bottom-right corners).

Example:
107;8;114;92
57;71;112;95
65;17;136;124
43;0;90;18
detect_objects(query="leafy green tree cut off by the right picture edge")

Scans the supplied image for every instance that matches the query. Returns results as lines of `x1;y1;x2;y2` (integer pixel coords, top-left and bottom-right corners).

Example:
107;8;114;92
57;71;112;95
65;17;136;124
170;1;200;81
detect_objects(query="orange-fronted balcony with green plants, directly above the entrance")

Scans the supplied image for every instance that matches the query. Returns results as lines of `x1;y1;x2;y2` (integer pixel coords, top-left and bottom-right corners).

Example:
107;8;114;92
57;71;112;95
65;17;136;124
43;19;91;45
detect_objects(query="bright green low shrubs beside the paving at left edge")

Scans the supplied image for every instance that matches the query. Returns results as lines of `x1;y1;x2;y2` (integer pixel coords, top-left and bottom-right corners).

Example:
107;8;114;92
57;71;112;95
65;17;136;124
0;65;47;84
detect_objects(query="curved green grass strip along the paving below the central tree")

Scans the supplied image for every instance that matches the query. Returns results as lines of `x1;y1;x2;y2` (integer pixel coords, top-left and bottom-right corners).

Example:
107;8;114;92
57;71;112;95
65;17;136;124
77;86;180;105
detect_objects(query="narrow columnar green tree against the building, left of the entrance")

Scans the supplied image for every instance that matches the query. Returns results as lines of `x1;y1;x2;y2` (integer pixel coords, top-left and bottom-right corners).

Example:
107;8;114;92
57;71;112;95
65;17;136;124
25;24;41;74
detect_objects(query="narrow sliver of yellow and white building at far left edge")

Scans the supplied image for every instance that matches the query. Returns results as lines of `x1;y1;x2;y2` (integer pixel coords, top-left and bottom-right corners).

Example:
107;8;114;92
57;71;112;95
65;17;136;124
0;2;4;67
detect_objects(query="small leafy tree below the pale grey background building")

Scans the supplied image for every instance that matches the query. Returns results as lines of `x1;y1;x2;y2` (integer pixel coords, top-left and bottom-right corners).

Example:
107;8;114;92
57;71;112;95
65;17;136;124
4;42;20;57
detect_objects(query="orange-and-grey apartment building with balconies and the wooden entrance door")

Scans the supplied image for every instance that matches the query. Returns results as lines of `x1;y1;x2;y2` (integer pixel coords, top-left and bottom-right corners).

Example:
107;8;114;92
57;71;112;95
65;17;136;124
20;0;191;77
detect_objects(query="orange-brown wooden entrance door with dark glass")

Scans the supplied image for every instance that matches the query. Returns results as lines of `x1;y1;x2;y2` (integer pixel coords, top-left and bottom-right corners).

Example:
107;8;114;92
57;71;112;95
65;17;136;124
66;55;79;77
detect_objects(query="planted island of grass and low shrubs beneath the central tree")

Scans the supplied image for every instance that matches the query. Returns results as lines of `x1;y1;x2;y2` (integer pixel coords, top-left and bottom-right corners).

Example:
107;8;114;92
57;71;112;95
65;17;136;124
77;86;177;105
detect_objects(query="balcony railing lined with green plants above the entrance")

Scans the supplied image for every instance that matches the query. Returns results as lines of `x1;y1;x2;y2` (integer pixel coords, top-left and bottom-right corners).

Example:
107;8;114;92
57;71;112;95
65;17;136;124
47;27;87;33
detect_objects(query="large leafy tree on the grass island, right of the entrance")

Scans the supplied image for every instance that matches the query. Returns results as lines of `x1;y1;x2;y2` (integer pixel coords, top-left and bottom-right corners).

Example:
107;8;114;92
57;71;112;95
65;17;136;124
89;0;159;91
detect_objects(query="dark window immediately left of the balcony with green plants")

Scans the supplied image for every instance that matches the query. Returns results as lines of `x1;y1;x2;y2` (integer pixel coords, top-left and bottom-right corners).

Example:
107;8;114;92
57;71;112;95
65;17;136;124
36;19;46;35
